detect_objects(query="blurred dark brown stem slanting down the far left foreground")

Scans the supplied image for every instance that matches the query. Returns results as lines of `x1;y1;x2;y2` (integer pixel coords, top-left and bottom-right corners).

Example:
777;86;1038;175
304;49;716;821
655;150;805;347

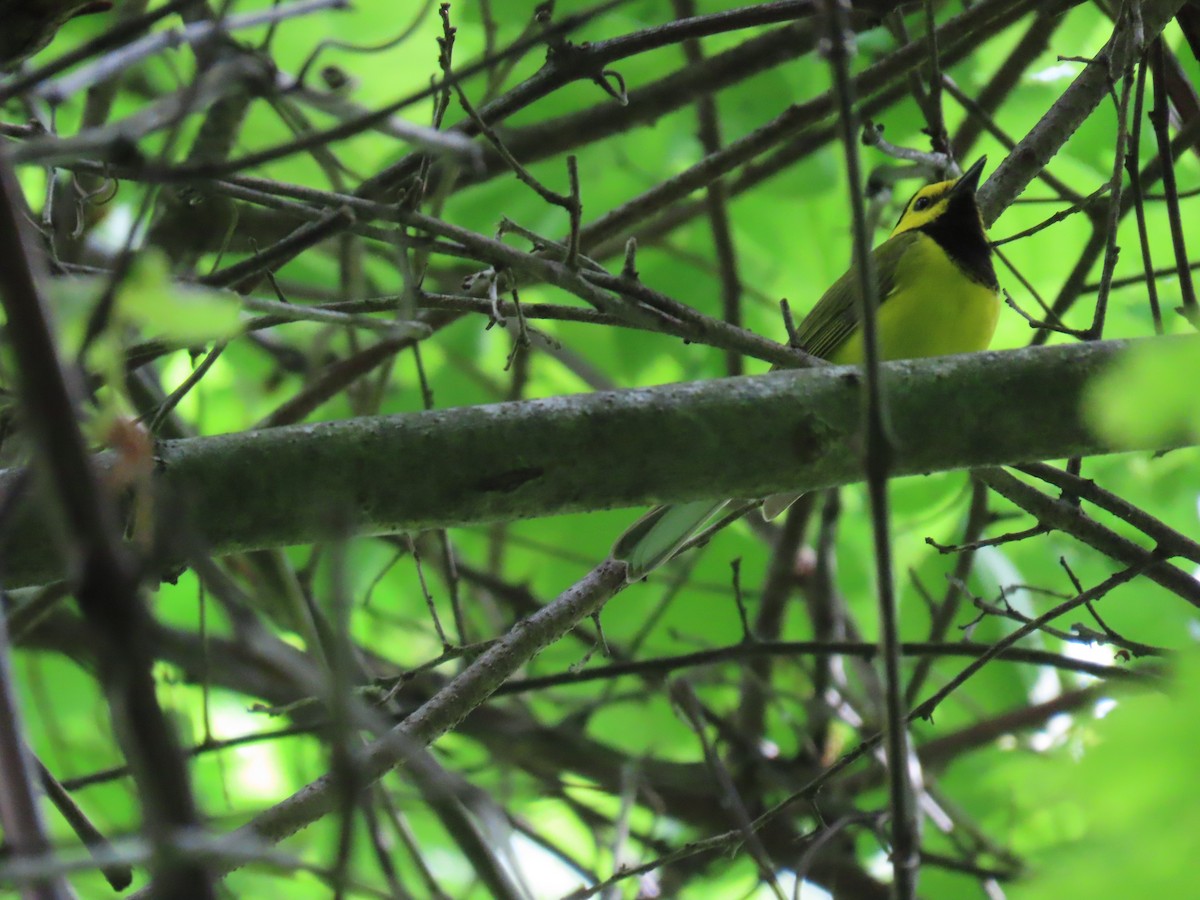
0;156;214;898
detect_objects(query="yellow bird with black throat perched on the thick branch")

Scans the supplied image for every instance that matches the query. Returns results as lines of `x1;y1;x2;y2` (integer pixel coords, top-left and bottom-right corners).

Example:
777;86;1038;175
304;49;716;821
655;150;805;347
612;157;1000;581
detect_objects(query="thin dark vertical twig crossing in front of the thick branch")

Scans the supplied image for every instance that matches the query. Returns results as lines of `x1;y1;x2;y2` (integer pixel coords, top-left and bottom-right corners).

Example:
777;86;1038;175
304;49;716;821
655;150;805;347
824;0;919;900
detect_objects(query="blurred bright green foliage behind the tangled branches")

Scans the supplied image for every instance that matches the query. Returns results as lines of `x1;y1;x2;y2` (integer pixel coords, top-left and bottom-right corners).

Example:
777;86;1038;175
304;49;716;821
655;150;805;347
9;0;1200;899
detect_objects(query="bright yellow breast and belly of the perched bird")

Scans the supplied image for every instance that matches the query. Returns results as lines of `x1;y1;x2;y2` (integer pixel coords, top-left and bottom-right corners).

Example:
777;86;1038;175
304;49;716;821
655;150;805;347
830;234;1000;365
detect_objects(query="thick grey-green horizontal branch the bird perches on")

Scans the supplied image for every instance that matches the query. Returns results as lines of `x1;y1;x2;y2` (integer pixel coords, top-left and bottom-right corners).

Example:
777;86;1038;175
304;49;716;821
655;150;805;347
0;338;1180;587
